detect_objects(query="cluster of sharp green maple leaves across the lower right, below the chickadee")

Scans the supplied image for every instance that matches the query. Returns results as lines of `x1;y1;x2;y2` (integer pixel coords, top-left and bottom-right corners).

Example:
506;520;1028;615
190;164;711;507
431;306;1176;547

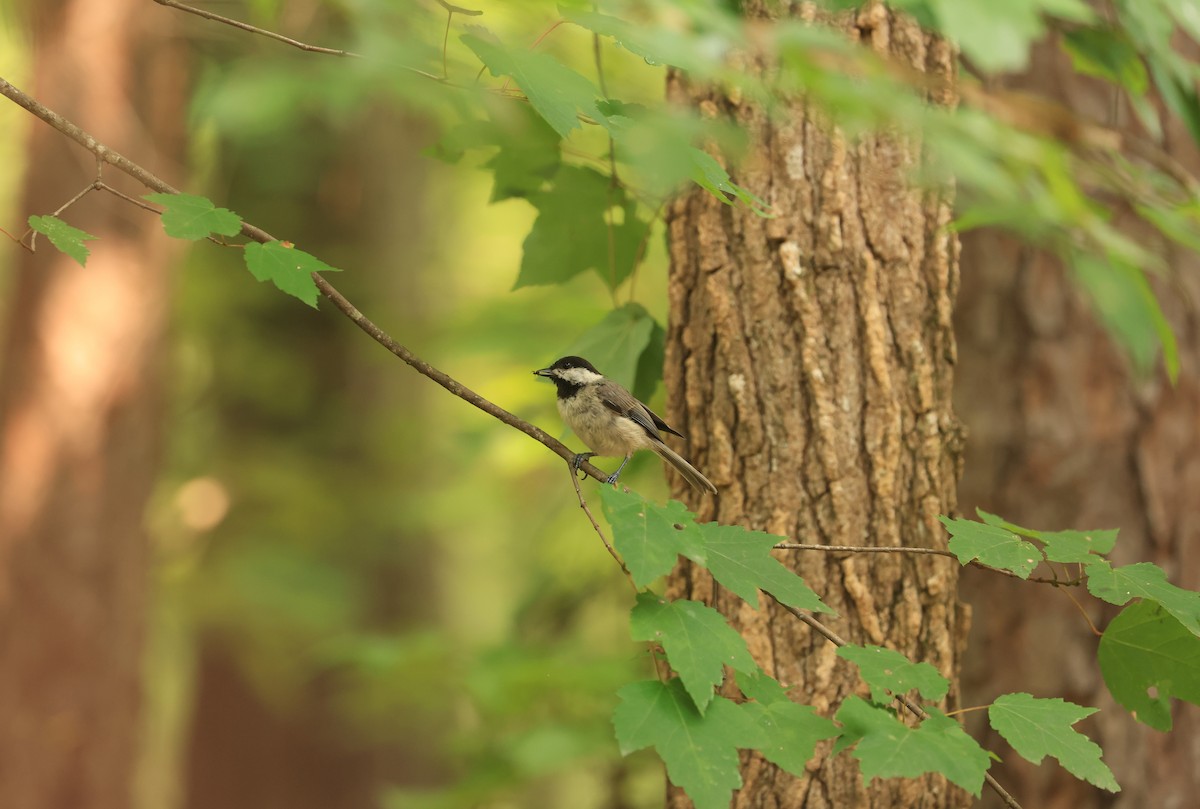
600;489;1161;809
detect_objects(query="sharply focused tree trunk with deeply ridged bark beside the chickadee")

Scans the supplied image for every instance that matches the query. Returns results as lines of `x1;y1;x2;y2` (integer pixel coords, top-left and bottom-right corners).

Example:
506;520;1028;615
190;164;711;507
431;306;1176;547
666;2;971;808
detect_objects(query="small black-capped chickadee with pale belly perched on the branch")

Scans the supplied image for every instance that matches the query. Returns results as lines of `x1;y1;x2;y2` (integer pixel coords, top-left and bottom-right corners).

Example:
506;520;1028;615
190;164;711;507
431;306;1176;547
534;356;716;495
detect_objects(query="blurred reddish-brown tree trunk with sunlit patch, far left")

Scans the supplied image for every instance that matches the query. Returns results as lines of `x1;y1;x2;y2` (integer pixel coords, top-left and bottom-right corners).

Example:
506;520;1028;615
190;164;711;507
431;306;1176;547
0;0;182;809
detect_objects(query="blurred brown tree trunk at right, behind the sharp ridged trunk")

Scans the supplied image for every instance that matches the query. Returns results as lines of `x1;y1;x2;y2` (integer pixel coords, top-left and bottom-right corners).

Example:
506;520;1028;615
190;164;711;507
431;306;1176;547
956;34;1200;809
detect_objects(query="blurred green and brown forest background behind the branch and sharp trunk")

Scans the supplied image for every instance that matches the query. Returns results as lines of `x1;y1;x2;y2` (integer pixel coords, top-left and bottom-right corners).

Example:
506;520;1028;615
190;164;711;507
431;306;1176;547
0;0;1200;809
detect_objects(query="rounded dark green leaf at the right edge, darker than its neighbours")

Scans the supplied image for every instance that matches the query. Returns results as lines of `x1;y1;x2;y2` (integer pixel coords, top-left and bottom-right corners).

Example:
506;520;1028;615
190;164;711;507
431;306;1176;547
1097;600;1200;732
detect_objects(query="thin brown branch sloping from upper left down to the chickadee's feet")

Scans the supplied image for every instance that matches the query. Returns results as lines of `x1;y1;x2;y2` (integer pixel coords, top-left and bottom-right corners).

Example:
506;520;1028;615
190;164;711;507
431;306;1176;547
0;77;608;483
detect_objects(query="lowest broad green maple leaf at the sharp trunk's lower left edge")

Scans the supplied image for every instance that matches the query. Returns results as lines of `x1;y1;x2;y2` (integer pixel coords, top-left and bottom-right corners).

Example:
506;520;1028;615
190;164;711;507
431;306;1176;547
612;679;763;809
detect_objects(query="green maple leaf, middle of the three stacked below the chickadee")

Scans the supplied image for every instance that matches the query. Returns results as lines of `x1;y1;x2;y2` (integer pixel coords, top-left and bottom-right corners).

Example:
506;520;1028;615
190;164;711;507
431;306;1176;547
630;593;757;713
